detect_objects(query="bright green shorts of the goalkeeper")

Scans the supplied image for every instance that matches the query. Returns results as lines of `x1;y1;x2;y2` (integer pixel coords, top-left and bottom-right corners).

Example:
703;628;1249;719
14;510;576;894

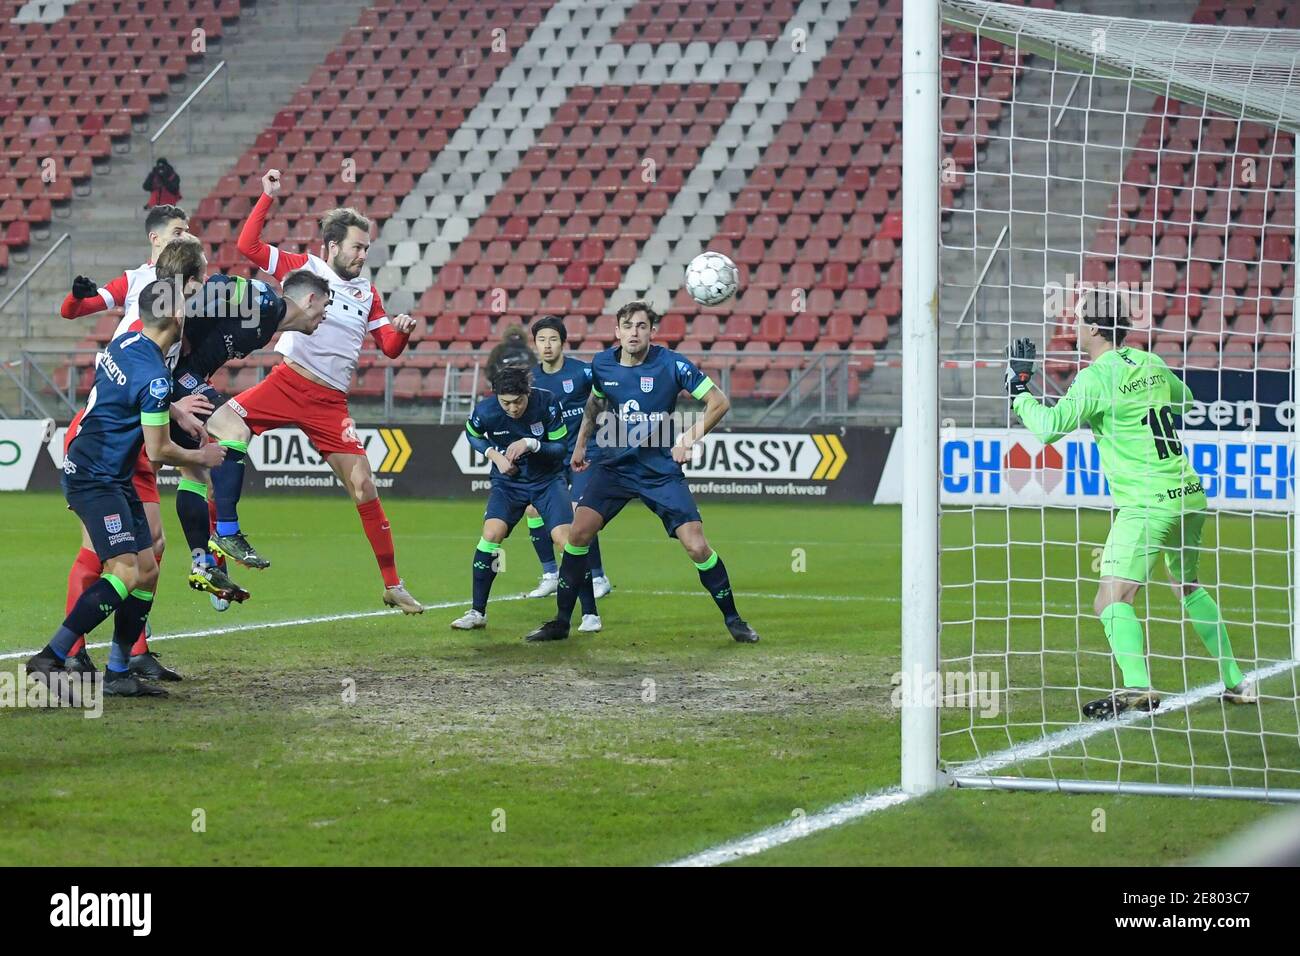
1101;507;1206;584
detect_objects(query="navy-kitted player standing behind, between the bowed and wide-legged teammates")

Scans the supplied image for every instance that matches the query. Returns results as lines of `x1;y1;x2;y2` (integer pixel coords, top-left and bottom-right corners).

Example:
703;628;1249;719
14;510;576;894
527;315;611;600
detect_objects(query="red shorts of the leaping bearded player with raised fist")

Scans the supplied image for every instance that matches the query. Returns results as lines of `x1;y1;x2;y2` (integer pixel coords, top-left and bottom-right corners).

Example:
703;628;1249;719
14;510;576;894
228;363;365;457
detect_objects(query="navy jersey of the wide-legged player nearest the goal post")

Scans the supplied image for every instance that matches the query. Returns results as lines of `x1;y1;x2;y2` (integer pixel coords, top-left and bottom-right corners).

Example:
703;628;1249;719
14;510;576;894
592;345;714;475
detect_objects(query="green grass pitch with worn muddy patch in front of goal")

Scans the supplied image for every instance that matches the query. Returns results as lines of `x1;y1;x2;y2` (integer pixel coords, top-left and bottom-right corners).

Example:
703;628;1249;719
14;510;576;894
0;494;1300;865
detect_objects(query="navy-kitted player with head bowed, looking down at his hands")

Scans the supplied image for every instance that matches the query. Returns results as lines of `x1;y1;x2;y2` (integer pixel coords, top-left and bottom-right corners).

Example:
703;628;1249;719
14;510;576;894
451;365;601;631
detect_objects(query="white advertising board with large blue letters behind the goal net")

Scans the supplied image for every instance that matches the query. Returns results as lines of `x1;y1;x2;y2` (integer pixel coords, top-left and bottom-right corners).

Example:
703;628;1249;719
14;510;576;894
875;428;1296;511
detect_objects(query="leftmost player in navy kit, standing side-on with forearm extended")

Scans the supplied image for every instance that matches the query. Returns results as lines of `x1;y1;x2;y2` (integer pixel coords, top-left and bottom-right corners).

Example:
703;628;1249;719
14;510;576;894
26;282;225;697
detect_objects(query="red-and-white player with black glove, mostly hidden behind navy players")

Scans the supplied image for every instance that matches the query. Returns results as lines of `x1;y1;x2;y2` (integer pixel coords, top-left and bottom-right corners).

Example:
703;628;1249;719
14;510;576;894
60;206;210;680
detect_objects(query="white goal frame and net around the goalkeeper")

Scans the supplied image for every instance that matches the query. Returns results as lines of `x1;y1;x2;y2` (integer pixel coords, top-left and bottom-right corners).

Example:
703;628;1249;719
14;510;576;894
904;0;1300;800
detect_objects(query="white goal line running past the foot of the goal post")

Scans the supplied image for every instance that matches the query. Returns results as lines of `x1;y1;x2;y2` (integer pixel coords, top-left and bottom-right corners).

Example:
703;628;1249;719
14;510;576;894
664;661;1300;866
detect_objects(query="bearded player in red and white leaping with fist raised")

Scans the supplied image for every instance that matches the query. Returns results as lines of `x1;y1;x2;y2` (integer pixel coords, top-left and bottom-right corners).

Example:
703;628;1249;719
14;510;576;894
208;169;424;614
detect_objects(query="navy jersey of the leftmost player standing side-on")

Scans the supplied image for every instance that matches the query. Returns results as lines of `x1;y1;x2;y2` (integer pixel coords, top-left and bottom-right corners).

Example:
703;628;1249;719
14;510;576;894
64;332;172;481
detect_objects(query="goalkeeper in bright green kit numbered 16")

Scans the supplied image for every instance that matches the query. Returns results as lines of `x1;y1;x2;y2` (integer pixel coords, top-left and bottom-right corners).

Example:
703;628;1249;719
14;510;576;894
1006;303;1258;719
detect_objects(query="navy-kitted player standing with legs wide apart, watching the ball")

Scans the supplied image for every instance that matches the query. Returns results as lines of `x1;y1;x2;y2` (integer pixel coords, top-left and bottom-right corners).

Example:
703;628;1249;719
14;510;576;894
524;302;758;644
